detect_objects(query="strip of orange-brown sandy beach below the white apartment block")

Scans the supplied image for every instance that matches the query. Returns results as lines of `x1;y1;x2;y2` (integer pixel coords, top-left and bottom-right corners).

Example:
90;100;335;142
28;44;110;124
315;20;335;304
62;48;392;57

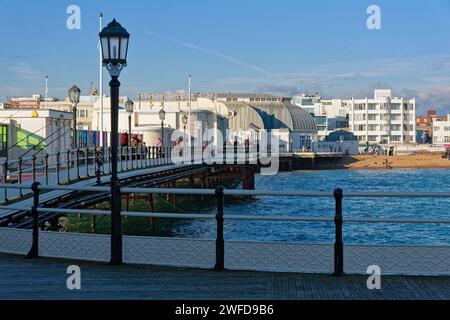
340;153;450;169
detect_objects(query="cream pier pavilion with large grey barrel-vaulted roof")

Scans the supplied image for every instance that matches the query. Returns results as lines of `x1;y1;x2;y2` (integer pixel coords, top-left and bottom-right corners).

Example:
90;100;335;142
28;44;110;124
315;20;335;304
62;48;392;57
93;93;317;152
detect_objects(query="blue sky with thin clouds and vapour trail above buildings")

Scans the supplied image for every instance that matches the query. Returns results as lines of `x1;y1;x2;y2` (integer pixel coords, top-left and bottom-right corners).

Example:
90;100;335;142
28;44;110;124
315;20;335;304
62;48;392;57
0;0;450;112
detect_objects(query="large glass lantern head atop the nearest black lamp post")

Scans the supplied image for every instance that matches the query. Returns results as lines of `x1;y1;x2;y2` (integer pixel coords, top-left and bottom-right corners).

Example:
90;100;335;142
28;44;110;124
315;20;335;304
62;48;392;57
100;19;130;75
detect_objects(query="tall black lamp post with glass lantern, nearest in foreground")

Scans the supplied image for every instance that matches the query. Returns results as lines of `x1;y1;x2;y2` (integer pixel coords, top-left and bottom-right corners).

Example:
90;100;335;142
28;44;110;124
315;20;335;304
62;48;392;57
99;19;130;265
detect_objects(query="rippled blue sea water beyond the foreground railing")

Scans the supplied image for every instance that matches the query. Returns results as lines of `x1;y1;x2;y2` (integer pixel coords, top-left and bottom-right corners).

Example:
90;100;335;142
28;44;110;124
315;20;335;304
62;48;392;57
172;169;450;245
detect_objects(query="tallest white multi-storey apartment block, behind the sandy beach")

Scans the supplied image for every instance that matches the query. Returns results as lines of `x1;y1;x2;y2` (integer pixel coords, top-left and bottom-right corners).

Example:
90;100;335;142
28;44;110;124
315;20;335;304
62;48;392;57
344;90;416;145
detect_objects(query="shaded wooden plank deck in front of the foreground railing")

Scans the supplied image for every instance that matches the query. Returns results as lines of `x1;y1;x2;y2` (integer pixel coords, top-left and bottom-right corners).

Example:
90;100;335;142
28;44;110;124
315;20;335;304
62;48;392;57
0;255;450;300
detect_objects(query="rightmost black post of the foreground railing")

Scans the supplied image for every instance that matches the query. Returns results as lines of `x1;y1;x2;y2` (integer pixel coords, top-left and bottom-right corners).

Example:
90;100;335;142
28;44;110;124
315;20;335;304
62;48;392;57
333;189;344;276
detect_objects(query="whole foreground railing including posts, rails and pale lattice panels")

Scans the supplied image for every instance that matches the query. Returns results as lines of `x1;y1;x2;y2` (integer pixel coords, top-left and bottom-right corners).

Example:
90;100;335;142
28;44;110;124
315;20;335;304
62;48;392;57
0;182;450;276
